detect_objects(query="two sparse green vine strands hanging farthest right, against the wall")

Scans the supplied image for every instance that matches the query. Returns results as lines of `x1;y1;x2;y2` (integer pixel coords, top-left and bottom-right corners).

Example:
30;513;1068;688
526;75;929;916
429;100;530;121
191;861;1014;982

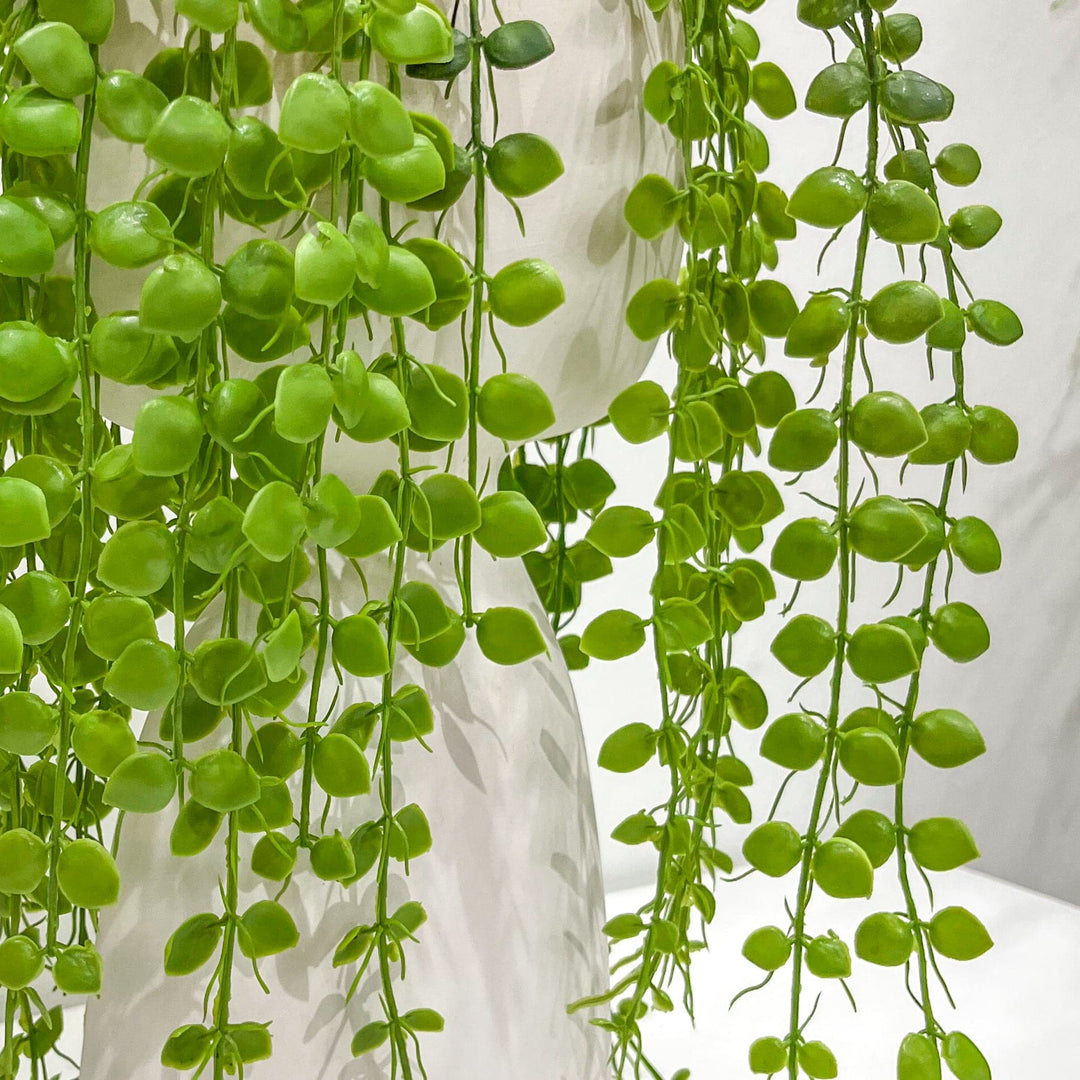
743;0;1022;1080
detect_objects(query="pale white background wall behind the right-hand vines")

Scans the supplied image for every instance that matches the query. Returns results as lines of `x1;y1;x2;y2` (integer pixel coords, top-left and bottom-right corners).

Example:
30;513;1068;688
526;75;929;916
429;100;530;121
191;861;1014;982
577;0;1080;902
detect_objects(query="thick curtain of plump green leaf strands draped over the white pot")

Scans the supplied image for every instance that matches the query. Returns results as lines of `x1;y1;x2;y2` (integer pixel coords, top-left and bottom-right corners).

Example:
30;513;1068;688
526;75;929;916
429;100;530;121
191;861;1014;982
0;0;564;1078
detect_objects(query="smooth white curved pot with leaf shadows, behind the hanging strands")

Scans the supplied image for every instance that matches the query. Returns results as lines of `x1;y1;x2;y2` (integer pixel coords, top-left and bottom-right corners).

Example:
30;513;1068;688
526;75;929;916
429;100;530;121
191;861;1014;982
81;0;678;1080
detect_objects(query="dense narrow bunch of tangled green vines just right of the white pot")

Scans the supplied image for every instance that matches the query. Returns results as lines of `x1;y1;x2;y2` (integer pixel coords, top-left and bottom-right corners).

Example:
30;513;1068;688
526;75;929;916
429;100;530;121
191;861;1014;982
565;2;795;1078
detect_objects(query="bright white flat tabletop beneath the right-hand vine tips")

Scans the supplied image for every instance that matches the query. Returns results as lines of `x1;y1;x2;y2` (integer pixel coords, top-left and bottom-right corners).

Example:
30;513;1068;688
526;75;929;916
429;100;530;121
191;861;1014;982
608;864;1080;1080
